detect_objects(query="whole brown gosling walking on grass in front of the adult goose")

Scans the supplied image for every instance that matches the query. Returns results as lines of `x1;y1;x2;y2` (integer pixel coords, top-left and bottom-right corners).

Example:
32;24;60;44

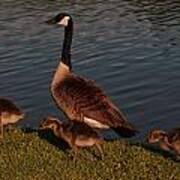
40;116;104;160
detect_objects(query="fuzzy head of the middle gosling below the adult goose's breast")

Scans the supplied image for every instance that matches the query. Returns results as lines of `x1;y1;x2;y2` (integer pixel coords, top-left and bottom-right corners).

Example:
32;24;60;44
39;116;61;130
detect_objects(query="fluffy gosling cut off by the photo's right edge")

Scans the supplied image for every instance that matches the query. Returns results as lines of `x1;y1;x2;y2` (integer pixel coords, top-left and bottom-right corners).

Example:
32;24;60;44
148;128;180;156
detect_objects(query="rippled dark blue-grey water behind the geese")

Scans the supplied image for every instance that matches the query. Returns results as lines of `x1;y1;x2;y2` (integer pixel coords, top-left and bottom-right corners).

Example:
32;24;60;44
0;0;180;139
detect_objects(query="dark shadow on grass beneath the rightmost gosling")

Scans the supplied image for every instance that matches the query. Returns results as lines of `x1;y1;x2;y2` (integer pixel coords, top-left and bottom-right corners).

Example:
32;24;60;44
130;142;180;163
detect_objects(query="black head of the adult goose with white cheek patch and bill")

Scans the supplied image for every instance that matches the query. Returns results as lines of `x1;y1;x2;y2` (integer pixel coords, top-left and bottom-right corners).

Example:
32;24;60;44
46;13;72;26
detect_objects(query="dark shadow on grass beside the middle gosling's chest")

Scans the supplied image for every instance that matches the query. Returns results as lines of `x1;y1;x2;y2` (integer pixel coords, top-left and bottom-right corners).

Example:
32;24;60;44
22;128;70;152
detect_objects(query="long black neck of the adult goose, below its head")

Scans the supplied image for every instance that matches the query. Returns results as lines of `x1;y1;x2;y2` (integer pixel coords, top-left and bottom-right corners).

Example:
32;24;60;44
61;19;73;69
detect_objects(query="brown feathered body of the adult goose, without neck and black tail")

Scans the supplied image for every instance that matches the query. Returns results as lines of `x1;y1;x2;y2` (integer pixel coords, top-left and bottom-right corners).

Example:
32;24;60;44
52;73;130;128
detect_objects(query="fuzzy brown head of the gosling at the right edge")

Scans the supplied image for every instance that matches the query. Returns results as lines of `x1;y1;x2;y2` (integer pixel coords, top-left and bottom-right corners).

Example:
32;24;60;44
148;129;167;144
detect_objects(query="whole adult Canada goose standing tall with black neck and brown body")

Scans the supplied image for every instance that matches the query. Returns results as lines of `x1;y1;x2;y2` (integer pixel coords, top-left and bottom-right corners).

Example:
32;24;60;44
47;13;137;137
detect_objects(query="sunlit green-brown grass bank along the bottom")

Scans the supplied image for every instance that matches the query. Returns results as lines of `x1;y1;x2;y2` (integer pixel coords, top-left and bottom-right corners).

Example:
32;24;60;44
0;129;180;180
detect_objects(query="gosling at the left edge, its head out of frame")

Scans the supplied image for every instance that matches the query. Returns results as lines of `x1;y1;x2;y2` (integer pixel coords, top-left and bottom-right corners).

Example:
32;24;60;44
0;98;24;139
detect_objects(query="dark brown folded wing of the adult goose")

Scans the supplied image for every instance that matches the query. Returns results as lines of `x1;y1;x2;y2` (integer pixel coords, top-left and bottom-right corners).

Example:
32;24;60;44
63;77;129;127
